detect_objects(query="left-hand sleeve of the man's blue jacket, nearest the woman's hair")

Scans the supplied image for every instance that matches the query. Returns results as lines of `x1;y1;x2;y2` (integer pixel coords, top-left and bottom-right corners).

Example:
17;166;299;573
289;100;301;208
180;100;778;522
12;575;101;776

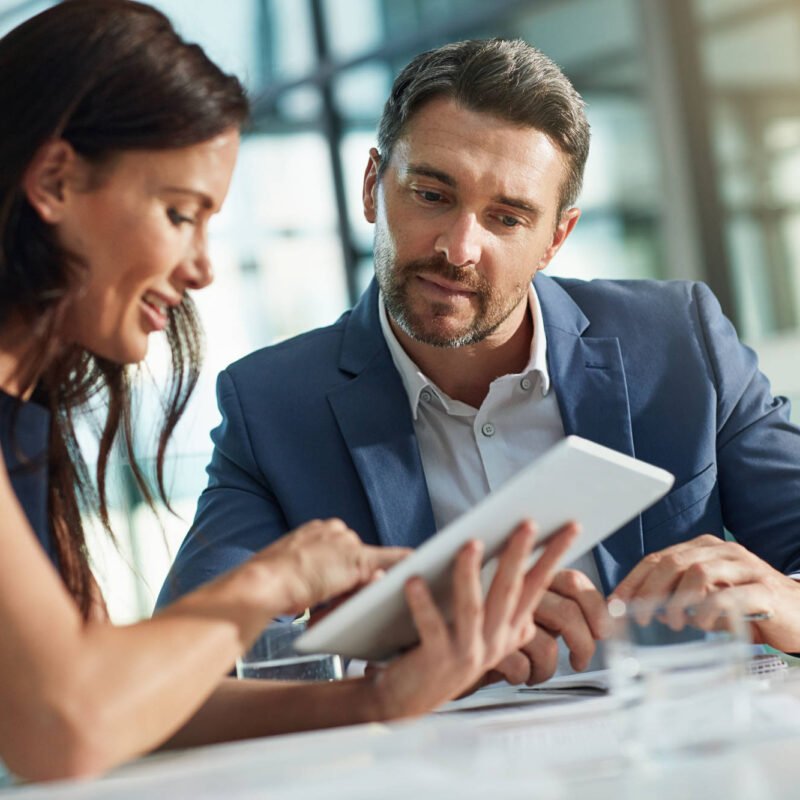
156;371;288;608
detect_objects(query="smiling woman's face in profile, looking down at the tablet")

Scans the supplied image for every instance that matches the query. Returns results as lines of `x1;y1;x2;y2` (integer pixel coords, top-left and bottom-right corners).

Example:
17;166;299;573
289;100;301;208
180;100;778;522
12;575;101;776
56;130;239;363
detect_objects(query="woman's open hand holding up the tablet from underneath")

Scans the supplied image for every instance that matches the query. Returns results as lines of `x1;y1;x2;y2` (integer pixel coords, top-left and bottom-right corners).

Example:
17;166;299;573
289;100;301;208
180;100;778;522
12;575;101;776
369;522;577;719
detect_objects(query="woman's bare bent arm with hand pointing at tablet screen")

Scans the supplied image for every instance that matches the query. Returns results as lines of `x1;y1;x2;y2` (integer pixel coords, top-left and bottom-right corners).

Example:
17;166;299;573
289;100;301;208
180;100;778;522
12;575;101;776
0;450;404;779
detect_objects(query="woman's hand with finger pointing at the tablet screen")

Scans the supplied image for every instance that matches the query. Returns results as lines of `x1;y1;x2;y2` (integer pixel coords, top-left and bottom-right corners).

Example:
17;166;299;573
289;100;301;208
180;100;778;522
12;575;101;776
253;519;411;614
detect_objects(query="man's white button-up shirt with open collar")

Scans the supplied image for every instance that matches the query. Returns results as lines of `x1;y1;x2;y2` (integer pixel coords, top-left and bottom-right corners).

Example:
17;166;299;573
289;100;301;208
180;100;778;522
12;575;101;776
379;284;602;674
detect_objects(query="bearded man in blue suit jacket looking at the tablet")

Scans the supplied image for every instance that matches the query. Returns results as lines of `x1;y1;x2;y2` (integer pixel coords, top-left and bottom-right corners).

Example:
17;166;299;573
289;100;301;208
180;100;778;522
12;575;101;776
160;40;800;682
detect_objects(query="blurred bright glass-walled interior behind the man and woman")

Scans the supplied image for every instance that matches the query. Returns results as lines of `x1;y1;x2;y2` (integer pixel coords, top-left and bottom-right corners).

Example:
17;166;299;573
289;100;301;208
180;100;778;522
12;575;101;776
0;0;800;622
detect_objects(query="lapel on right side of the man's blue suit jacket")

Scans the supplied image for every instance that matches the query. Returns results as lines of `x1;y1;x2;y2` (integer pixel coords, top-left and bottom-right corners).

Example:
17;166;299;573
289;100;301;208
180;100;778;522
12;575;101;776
536;275;644;592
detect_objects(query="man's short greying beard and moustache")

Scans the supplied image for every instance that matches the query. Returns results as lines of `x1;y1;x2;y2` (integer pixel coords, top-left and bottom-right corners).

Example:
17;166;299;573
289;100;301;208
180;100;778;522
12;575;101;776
374;227;527;347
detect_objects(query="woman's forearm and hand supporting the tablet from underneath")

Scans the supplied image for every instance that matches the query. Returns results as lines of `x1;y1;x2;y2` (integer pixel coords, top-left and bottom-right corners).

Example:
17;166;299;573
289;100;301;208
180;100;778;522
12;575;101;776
166;524;575;747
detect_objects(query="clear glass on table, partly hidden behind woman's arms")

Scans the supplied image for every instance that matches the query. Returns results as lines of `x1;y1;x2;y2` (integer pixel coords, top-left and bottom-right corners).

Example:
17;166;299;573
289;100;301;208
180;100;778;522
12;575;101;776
236;618;343;681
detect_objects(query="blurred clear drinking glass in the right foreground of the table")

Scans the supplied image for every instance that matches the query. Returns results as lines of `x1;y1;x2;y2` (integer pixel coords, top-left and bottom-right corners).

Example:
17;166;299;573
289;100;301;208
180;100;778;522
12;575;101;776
606;598;752;756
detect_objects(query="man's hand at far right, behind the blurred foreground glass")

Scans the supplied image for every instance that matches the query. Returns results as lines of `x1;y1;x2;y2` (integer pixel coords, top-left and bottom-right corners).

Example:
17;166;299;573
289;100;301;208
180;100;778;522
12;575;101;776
609;534;800;652
